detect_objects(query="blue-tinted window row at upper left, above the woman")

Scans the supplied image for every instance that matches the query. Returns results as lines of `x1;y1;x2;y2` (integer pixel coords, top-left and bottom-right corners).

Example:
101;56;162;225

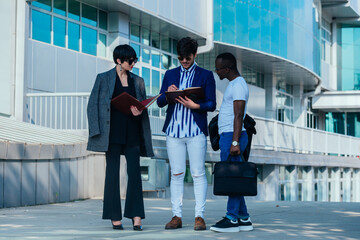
31;0;108;57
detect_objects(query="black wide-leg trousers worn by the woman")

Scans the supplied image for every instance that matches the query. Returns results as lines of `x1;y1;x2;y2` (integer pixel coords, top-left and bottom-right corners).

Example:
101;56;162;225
102;144;145;221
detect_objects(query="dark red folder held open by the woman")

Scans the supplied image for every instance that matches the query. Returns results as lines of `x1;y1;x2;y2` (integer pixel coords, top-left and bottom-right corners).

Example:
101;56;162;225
111;92;161;115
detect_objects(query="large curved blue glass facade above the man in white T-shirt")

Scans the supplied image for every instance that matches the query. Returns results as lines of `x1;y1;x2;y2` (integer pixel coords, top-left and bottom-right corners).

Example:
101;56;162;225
214;0;320;75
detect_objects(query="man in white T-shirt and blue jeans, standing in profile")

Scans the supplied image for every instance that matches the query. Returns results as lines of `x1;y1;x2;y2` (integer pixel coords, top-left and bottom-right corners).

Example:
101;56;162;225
210;53;253;232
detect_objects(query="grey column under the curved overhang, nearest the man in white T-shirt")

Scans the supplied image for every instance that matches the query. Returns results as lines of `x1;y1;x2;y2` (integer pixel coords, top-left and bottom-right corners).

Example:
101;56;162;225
264;74;276;119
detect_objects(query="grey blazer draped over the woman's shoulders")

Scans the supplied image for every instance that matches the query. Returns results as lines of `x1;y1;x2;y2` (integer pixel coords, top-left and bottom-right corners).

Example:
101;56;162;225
87;68;154;157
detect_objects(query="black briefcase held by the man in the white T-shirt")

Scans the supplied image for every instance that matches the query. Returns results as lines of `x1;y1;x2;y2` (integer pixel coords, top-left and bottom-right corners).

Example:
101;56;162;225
213;155;258;196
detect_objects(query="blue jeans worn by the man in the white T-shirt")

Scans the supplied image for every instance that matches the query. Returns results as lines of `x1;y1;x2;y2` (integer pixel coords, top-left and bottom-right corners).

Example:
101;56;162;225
219;131;249;220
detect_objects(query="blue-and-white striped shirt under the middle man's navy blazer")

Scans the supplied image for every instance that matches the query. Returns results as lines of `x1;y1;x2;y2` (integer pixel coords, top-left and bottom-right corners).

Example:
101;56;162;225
166;63;202;138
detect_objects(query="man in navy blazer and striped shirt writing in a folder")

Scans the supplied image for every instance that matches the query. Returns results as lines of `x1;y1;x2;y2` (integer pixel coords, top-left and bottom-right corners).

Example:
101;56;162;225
157;37;216;230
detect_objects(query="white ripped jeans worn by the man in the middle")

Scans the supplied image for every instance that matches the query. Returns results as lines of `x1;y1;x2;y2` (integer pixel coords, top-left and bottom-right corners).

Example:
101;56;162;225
166;134;208;218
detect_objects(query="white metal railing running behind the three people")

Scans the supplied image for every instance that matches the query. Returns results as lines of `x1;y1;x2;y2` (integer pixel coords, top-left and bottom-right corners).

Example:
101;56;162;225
26;93;360;156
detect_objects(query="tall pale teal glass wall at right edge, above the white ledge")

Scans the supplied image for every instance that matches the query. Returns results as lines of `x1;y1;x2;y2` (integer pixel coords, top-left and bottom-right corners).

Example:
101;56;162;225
338;25;360;91
